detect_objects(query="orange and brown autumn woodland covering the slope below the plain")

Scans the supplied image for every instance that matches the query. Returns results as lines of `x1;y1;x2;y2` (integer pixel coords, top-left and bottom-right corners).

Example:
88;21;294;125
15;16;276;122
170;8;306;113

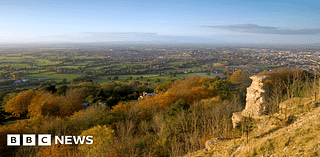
0;66;319;156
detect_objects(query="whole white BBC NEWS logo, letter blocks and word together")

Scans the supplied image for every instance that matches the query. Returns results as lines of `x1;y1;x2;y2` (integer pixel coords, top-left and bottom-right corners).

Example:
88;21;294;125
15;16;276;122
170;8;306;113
7;134;93;146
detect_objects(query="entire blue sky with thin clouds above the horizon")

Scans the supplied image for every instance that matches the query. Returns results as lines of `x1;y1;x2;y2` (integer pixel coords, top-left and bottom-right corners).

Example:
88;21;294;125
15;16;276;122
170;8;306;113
0;0;320;44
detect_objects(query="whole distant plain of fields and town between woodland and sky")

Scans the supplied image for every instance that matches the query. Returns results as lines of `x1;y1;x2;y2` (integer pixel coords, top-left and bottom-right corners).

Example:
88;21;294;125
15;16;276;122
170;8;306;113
0;44;320;91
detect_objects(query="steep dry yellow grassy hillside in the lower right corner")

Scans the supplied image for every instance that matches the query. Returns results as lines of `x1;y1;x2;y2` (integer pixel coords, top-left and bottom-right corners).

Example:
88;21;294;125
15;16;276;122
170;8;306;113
186;98;320;156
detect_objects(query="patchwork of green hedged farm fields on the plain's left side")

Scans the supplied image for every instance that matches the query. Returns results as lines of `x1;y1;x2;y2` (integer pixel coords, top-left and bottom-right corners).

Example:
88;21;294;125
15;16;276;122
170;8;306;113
0;48;224;91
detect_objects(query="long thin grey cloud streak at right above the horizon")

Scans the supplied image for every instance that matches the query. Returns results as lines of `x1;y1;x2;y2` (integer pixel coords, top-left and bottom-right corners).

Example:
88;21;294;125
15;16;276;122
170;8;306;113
202;24;320;35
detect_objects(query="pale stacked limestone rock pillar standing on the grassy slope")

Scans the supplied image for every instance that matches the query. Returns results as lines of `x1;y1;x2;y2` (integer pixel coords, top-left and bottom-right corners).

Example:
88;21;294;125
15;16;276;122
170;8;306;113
232;76;267;128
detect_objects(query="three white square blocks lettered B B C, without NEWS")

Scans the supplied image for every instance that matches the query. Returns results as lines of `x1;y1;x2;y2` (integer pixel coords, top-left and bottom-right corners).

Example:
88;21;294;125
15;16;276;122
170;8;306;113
7;134;51;146
